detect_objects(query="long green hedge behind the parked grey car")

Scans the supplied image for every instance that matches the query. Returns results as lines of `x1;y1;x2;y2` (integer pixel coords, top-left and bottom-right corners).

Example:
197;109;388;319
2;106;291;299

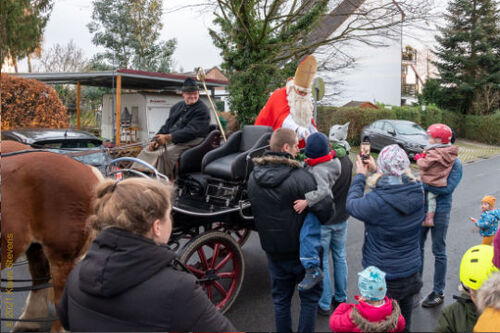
317;106;500;145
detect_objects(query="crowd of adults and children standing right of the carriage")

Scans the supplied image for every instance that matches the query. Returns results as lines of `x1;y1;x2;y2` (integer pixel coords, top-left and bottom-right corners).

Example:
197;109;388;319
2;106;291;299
248;124;500;332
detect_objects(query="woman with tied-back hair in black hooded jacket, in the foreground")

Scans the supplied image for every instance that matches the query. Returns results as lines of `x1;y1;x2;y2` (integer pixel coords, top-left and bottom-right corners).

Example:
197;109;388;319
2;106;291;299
58;178;235;332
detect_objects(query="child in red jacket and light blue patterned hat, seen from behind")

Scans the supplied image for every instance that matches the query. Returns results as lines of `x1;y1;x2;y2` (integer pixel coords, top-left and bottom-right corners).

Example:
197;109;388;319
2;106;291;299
330;266;405;332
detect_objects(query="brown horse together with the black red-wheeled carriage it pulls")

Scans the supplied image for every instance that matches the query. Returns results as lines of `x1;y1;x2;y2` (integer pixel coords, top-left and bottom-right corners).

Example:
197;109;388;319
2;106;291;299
1;126;272;330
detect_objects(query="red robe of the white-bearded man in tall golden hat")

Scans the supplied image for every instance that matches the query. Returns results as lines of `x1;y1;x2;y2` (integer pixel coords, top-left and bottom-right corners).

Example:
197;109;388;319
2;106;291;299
255;86;316;148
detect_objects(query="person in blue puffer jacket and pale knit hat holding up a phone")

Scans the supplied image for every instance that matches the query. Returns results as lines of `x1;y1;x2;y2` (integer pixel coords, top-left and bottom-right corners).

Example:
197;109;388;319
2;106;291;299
346;145;425;330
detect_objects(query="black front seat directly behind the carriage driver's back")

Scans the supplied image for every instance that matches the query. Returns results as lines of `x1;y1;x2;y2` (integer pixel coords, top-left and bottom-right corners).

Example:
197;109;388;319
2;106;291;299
177;125;221;175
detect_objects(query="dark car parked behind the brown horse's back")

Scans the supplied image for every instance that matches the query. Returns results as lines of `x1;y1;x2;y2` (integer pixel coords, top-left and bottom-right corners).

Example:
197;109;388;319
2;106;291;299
2;128;111;174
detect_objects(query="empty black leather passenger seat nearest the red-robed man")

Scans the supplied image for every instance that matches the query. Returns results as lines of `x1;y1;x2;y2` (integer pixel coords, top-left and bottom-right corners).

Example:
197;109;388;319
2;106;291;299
202;125;273;180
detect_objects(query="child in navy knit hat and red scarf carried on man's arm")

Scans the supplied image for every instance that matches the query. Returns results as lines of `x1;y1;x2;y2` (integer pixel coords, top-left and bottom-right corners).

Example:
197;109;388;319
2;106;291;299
293;132;341;290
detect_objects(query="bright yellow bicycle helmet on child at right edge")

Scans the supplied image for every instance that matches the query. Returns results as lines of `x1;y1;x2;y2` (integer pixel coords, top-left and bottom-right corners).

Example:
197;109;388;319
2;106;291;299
460;245;498;290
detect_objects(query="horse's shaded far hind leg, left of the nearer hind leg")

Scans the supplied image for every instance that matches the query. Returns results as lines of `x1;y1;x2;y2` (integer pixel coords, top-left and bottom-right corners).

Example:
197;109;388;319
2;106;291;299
14;243;50;332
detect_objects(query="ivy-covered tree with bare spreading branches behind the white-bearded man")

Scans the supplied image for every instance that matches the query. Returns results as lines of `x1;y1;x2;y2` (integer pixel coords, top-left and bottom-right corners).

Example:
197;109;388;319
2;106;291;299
167;0;436;123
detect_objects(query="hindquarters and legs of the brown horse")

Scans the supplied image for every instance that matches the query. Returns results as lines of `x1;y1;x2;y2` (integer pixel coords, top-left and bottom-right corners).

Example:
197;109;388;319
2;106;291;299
1;141;102;331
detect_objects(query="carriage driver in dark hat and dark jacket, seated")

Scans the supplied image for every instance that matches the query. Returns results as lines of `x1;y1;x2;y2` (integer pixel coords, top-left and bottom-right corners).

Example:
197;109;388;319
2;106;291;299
133;77;210;179
